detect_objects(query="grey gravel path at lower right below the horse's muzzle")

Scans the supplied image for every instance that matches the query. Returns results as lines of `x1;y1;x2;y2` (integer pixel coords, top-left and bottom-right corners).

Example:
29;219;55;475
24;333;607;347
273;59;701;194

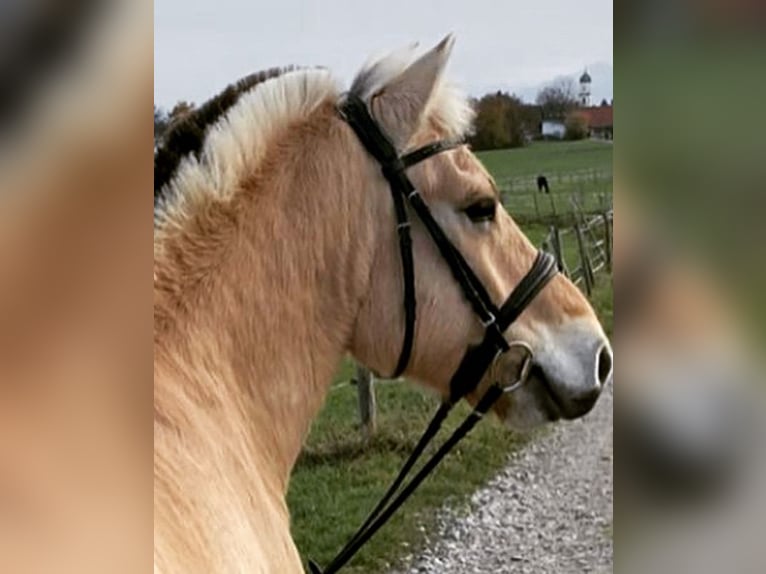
405;385;613;574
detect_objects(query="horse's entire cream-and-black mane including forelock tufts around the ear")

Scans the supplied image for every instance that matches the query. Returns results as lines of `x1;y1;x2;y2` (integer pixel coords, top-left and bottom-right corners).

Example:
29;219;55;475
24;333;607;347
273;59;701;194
154;46;474;233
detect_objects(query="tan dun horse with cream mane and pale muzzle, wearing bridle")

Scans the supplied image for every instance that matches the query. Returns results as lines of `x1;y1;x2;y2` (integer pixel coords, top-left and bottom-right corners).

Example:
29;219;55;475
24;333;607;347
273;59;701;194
154;36;612;574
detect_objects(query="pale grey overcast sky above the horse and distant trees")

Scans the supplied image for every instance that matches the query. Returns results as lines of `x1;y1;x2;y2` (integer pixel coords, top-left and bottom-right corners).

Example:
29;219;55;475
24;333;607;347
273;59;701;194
154;0;613;108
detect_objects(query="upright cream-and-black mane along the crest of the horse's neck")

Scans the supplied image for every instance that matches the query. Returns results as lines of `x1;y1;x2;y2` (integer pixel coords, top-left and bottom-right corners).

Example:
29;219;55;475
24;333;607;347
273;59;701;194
154;67;338;227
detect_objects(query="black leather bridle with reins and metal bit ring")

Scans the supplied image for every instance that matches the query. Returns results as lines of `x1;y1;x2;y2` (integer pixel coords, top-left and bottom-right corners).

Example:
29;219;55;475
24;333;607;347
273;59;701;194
309;94;558;574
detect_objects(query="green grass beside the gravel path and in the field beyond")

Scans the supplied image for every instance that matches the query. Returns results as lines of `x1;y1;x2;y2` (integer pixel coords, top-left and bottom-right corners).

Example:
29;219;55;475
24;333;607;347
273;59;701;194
288;142;613;574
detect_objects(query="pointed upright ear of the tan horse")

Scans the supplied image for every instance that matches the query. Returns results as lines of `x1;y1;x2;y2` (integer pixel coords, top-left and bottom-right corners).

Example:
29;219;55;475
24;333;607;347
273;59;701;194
370;34;455;150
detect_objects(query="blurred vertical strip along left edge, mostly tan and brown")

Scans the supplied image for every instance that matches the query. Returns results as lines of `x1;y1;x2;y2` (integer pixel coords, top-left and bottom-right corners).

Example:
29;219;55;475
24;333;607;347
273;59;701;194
0;0;153;574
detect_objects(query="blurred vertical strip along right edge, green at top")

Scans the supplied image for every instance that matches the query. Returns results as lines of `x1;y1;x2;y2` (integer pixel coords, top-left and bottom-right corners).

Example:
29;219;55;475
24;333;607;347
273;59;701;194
614;1;766;574
